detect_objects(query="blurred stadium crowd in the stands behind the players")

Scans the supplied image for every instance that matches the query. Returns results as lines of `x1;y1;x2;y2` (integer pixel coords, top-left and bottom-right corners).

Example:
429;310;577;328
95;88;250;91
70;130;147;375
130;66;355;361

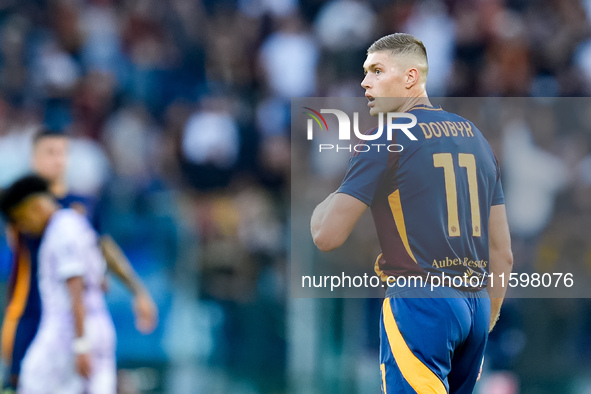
0;0;591;394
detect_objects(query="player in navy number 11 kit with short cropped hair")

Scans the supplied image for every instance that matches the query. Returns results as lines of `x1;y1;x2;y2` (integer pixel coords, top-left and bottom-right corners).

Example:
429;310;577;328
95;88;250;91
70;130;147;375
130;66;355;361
311;33;513;394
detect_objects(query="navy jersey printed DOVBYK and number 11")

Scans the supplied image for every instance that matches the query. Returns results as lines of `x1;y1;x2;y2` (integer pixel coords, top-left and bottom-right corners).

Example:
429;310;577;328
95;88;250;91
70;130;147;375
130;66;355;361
338;105;504;283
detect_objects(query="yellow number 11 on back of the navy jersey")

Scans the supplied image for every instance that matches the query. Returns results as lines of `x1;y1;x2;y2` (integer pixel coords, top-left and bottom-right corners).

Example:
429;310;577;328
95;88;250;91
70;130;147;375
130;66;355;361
433;153;481;237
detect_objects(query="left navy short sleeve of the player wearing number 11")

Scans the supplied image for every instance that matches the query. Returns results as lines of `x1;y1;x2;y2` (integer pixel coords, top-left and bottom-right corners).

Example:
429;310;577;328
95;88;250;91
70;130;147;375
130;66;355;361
337;149;387;206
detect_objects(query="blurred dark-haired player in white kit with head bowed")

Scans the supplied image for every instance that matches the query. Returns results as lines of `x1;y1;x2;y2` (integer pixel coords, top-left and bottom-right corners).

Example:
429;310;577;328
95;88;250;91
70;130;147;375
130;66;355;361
0;175;116;394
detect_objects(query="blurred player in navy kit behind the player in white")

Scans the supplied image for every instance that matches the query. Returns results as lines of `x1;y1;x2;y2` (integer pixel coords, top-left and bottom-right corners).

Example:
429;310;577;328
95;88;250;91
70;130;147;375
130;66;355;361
2;129;158;393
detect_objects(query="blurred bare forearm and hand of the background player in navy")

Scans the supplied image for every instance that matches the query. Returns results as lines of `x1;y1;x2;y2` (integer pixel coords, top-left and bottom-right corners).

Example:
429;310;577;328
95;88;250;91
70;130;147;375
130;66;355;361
100;235;158;334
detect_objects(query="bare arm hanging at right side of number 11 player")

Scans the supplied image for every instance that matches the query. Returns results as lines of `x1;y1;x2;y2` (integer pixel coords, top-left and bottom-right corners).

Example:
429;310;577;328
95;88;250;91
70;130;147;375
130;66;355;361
488;204;513;331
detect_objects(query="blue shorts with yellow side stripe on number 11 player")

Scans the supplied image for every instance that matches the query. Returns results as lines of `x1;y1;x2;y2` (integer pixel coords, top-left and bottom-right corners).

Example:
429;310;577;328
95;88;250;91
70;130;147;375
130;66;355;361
380;287;490;394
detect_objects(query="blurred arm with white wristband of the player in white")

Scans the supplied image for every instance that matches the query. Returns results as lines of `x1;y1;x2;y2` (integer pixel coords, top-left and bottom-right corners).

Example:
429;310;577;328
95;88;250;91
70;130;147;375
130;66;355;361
66;276;91;378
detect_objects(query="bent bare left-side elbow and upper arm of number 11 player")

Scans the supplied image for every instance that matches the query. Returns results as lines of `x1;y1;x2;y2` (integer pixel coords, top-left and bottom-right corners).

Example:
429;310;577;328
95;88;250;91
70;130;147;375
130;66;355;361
310;192;367;252
